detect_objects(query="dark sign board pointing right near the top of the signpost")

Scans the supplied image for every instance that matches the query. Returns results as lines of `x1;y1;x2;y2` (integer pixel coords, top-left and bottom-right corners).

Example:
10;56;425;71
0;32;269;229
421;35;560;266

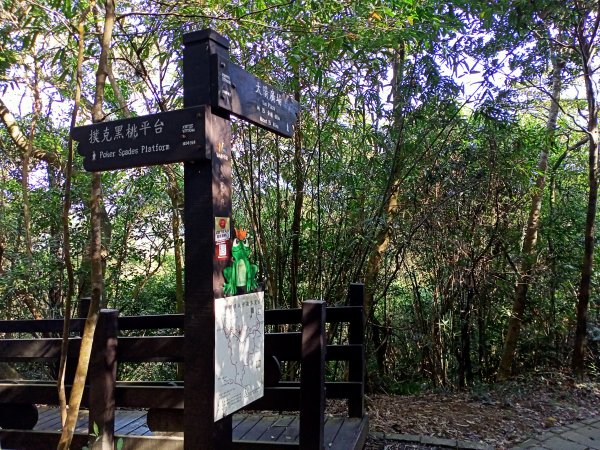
213;57;300;137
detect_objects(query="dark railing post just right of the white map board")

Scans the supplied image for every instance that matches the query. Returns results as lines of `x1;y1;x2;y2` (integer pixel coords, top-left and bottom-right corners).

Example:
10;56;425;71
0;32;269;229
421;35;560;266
300;300;326;450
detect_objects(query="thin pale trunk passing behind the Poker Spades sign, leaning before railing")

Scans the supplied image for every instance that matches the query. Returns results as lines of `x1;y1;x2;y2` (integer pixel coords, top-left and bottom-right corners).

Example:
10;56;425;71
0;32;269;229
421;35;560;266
58;0;115;450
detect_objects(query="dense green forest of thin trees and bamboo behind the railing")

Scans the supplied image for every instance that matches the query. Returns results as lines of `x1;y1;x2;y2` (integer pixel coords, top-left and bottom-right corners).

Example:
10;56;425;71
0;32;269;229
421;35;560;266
0;0;600;393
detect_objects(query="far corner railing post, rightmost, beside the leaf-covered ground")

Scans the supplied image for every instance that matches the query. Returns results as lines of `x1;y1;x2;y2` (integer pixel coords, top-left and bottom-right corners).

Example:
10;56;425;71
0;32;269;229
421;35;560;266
348;283;366;417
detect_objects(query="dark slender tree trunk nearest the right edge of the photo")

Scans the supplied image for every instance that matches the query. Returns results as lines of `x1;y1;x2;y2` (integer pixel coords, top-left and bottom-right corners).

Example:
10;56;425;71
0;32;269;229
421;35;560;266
571;13;600;377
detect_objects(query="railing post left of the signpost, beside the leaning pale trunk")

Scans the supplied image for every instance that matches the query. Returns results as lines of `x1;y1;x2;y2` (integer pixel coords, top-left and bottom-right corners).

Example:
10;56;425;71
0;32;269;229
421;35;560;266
88;309;119;450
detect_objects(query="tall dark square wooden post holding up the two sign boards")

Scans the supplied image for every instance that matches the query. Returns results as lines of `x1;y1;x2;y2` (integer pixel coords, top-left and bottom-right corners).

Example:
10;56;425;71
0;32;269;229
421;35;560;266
183;30;232;450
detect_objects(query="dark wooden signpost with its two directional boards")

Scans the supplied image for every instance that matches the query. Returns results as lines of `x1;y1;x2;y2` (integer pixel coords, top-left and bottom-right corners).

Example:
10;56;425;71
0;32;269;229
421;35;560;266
72;30;299;450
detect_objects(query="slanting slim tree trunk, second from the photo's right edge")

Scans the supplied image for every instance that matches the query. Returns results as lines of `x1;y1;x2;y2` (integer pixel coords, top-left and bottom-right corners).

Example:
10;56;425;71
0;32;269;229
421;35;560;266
497;50;564;381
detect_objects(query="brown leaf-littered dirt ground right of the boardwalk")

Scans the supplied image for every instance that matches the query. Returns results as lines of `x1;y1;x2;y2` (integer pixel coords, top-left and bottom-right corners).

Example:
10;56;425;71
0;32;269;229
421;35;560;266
330;374;600;450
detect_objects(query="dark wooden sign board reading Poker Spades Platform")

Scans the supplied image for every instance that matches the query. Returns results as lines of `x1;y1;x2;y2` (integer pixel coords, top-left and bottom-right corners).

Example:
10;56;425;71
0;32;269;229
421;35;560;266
71;106;210;172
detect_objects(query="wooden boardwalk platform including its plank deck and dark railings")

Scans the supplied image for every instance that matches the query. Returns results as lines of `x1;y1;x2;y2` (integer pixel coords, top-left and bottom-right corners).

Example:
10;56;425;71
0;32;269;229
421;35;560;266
0;284;369;450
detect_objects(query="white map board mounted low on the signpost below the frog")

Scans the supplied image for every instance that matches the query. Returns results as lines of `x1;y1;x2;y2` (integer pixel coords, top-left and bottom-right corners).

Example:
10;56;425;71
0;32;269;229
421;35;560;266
214;292;265;422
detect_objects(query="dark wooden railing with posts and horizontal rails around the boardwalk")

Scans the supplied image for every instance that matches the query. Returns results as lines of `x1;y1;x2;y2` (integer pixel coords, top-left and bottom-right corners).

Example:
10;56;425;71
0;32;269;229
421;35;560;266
0;284;365;449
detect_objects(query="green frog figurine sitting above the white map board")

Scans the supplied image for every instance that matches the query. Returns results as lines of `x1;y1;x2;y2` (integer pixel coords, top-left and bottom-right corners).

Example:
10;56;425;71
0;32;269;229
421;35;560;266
223;228;258;295
